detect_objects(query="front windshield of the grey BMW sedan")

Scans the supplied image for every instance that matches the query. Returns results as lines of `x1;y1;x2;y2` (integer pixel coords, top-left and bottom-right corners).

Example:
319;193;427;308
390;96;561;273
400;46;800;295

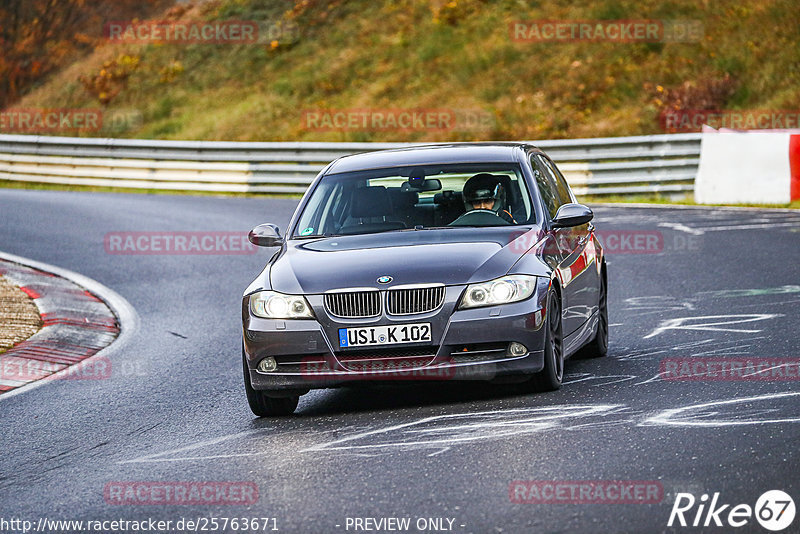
293;163;536;238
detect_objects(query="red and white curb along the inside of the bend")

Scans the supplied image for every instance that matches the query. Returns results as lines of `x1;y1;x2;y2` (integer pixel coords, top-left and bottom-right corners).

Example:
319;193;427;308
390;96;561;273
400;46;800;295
0;252;139;400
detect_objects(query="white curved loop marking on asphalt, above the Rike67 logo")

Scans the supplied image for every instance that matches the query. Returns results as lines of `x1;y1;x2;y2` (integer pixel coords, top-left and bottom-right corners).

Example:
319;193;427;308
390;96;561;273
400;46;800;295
639;391;800;427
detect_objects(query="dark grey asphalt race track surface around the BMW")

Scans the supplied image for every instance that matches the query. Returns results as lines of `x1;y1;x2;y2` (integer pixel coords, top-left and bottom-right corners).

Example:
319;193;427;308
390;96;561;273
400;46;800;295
0;190;800;533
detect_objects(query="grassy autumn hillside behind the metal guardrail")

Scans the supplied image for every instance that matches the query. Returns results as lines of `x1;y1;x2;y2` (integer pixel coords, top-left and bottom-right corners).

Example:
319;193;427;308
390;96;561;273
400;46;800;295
11;0;800;141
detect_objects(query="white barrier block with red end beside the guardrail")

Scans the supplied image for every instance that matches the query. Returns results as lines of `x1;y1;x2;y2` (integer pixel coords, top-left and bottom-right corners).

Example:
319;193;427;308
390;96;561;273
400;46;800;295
694;130;800;204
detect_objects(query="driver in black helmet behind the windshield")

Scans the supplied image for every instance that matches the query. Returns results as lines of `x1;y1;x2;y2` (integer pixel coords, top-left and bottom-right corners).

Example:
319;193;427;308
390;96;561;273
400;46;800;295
450;173;516;226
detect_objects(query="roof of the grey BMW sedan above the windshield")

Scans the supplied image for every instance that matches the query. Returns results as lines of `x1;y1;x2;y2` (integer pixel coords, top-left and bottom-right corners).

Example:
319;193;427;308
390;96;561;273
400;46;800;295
326;143;539;174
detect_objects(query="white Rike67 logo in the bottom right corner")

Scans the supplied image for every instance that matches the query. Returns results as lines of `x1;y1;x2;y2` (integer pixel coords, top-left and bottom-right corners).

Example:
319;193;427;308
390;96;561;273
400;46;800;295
667;490;795;532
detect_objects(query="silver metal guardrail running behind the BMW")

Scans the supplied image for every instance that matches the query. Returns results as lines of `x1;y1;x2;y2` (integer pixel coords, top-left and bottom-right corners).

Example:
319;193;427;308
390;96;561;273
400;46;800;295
0;134;700;195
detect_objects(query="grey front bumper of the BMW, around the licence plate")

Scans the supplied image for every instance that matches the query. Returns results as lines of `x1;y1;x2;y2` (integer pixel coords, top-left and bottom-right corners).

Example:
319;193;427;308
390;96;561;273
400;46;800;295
242;279;549;392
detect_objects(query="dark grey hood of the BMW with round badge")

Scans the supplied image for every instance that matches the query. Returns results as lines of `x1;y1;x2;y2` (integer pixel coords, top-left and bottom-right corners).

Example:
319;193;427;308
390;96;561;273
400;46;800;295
269;226;544;294
